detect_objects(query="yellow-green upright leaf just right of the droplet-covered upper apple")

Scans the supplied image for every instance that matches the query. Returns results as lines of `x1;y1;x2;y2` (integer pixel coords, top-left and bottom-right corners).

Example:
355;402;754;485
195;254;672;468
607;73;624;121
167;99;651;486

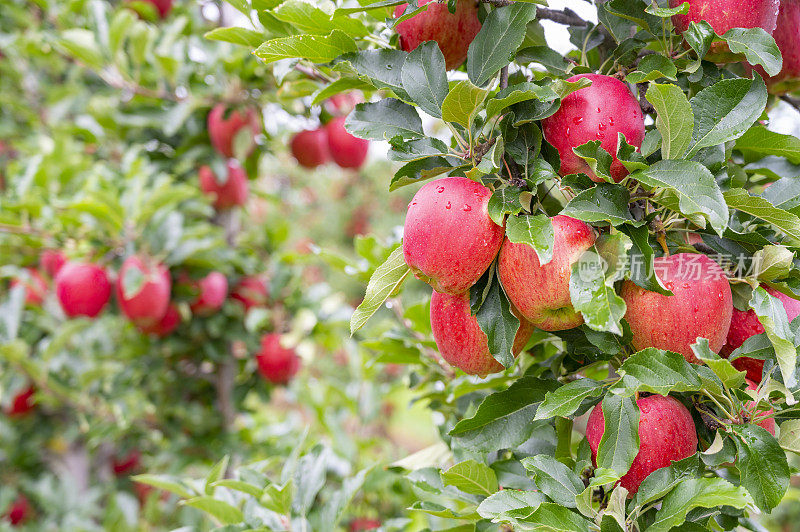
646;83;694;159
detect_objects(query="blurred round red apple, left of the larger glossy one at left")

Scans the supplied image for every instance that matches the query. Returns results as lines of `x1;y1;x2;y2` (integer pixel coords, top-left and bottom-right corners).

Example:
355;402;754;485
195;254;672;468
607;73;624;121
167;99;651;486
55;261;111;318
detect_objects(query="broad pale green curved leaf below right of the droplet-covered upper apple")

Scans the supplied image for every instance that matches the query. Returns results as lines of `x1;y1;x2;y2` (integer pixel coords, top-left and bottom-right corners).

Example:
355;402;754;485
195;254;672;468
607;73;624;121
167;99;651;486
632;160;728;235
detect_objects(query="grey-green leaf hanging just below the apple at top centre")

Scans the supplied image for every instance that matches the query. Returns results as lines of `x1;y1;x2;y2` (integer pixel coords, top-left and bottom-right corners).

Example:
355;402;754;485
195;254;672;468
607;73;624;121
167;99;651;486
401;41;449;118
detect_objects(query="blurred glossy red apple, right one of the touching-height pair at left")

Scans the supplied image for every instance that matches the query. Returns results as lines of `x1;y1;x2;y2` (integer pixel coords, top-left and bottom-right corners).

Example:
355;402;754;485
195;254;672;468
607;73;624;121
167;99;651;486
116;255;172;327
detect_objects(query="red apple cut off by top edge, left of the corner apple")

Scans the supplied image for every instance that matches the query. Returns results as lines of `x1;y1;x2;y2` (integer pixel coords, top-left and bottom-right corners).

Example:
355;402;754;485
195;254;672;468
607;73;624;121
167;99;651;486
669;0;781;58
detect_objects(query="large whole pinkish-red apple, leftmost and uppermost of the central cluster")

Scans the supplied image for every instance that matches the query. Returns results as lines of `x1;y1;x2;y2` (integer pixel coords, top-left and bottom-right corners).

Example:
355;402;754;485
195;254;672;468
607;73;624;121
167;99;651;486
403;177;505;295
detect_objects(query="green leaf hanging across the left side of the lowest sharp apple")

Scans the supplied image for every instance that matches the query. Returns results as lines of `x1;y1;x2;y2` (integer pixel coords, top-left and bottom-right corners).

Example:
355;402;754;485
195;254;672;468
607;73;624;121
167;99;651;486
597;393;639;476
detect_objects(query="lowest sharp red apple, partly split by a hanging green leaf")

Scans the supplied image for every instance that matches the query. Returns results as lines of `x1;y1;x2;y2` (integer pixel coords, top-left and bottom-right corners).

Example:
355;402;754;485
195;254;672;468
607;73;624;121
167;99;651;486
586;395;697;497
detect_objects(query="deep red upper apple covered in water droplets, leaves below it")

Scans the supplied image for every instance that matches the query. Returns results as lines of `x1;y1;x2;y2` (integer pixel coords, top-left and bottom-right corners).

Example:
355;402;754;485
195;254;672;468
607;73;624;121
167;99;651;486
542;74;645;183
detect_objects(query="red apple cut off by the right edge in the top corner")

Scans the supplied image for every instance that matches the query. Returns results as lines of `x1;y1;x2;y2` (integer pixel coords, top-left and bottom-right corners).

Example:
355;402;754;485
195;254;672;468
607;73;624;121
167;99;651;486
745;0;800;94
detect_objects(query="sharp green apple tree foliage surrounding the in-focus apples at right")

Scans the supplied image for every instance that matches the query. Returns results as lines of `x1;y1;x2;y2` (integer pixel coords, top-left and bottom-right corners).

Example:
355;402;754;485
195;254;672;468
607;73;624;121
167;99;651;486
188;0;800;532
